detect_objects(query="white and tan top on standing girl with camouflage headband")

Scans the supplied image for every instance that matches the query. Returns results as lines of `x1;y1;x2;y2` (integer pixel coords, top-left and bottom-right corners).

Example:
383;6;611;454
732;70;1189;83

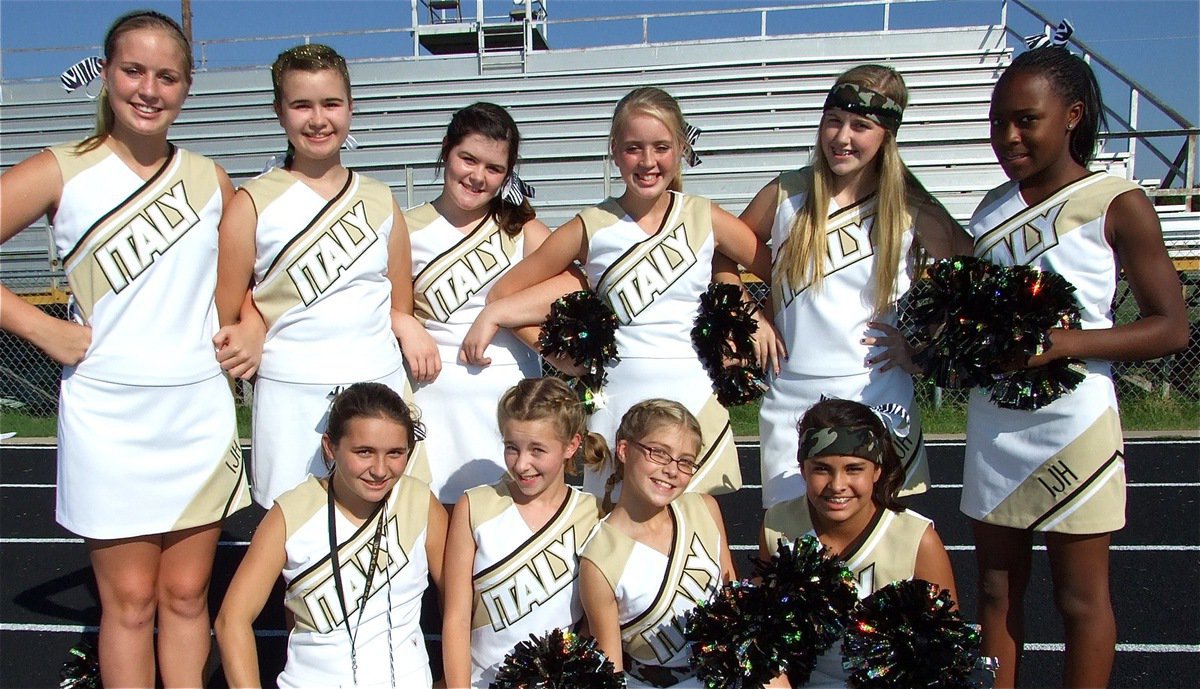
770;168;918;378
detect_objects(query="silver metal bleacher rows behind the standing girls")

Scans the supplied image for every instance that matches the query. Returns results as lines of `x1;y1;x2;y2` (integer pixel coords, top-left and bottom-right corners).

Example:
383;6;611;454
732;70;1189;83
0;20;1010;295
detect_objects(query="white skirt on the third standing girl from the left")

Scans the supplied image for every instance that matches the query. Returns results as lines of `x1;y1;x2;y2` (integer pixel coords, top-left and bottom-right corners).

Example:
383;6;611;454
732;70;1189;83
406;358;539;504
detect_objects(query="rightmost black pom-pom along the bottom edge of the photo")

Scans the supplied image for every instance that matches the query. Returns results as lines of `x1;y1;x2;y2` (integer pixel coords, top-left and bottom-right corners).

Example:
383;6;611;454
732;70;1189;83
841;580;994;689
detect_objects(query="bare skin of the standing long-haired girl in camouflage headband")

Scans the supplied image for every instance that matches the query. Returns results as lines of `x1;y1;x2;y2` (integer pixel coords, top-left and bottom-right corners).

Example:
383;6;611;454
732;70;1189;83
714;108;972;373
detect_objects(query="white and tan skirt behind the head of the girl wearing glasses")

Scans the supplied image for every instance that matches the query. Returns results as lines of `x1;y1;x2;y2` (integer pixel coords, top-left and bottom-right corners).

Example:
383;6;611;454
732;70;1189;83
583;358;742;503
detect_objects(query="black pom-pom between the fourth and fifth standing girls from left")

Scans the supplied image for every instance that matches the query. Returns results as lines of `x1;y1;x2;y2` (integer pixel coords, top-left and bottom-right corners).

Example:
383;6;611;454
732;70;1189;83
691;282;767;407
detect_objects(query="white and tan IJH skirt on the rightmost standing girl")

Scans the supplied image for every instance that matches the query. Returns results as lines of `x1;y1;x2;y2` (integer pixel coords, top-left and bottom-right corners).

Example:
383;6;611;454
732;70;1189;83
961;361;1126;534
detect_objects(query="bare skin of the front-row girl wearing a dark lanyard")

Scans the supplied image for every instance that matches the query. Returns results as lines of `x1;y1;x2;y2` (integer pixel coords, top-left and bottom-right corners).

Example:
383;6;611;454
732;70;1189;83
214;417;446;688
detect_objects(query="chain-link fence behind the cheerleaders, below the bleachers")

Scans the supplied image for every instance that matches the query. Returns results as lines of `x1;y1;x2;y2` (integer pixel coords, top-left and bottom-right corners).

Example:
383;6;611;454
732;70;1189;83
0;270;1200;424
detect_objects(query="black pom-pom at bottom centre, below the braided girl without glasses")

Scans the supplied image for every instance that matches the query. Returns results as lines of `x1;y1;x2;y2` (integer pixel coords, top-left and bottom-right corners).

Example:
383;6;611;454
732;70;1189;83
488;629;625;689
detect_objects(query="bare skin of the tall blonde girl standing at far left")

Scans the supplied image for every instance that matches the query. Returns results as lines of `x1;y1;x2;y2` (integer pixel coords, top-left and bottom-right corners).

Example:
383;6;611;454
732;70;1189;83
0;28;243;687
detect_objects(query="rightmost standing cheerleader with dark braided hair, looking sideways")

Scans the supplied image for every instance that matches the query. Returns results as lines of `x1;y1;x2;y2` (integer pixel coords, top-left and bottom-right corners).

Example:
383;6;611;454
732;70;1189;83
961;47;1188;688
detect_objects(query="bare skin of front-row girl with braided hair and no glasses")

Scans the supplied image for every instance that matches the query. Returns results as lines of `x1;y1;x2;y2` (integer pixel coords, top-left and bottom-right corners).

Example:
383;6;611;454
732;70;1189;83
442;418;582;689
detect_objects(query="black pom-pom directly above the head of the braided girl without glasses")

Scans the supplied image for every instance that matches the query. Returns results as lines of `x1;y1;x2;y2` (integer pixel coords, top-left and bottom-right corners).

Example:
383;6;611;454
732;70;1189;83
538;289;620;412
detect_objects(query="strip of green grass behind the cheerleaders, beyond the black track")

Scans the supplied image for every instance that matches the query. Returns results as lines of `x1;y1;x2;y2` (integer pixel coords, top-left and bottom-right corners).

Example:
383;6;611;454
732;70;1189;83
0;389;1200;438
